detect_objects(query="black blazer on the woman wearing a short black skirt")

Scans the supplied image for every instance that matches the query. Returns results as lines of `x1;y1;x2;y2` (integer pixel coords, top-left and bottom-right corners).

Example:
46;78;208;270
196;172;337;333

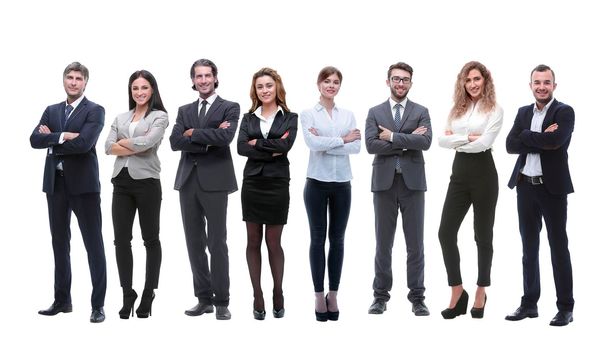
237;111;297;178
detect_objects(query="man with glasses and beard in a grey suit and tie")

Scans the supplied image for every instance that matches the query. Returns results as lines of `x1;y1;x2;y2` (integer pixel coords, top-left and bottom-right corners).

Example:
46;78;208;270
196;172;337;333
365;62;432;316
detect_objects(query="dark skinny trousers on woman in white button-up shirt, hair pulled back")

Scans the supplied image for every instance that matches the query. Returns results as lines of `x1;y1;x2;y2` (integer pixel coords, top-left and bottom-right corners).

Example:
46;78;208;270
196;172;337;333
304;178;352;292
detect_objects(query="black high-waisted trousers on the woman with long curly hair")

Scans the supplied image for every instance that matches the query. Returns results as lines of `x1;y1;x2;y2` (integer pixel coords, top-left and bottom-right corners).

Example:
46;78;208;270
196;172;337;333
438;150;499;287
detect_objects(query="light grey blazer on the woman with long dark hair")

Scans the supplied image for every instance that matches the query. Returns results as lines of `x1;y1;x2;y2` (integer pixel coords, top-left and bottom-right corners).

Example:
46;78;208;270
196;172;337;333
105;110;169;179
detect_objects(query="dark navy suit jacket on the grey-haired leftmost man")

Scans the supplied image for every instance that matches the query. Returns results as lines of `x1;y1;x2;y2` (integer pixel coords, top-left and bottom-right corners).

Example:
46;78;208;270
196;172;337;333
30;97;105;195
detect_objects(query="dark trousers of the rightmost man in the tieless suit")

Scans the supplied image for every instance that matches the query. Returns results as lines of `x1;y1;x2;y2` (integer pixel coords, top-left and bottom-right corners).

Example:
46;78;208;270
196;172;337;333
516;181;574;311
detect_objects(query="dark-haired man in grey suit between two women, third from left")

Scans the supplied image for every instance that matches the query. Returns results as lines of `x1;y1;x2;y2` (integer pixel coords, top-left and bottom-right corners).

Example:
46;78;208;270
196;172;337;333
170;59;240;320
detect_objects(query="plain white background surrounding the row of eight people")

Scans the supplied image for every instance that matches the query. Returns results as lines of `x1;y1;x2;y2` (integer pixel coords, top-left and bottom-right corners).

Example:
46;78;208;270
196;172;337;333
0;0;607;349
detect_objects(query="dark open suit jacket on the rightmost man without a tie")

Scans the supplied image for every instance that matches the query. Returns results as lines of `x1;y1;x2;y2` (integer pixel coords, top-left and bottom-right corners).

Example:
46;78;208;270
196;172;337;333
506;99;575;195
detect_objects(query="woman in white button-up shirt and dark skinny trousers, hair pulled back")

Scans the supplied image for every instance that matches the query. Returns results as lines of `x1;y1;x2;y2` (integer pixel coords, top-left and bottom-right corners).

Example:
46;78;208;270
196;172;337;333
301;67;361;322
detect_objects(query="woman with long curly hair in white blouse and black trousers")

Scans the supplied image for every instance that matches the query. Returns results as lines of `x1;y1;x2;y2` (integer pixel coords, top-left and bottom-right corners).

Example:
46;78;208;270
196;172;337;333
438;61;503;319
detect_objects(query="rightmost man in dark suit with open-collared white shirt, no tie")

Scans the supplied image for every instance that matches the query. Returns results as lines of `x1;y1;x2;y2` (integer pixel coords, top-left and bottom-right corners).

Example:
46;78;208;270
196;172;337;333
506;65;575;326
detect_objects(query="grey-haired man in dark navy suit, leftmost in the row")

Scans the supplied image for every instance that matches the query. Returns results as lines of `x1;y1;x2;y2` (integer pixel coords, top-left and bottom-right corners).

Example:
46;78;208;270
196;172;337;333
30;62;107;323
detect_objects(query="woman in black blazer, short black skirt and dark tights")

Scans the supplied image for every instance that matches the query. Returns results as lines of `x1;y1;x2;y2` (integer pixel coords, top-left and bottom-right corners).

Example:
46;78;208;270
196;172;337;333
238;68;297;320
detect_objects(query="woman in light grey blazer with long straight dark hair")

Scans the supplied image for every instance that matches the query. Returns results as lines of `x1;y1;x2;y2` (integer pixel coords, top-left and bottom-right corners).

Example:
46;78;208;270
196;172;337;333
105;70;169;319
